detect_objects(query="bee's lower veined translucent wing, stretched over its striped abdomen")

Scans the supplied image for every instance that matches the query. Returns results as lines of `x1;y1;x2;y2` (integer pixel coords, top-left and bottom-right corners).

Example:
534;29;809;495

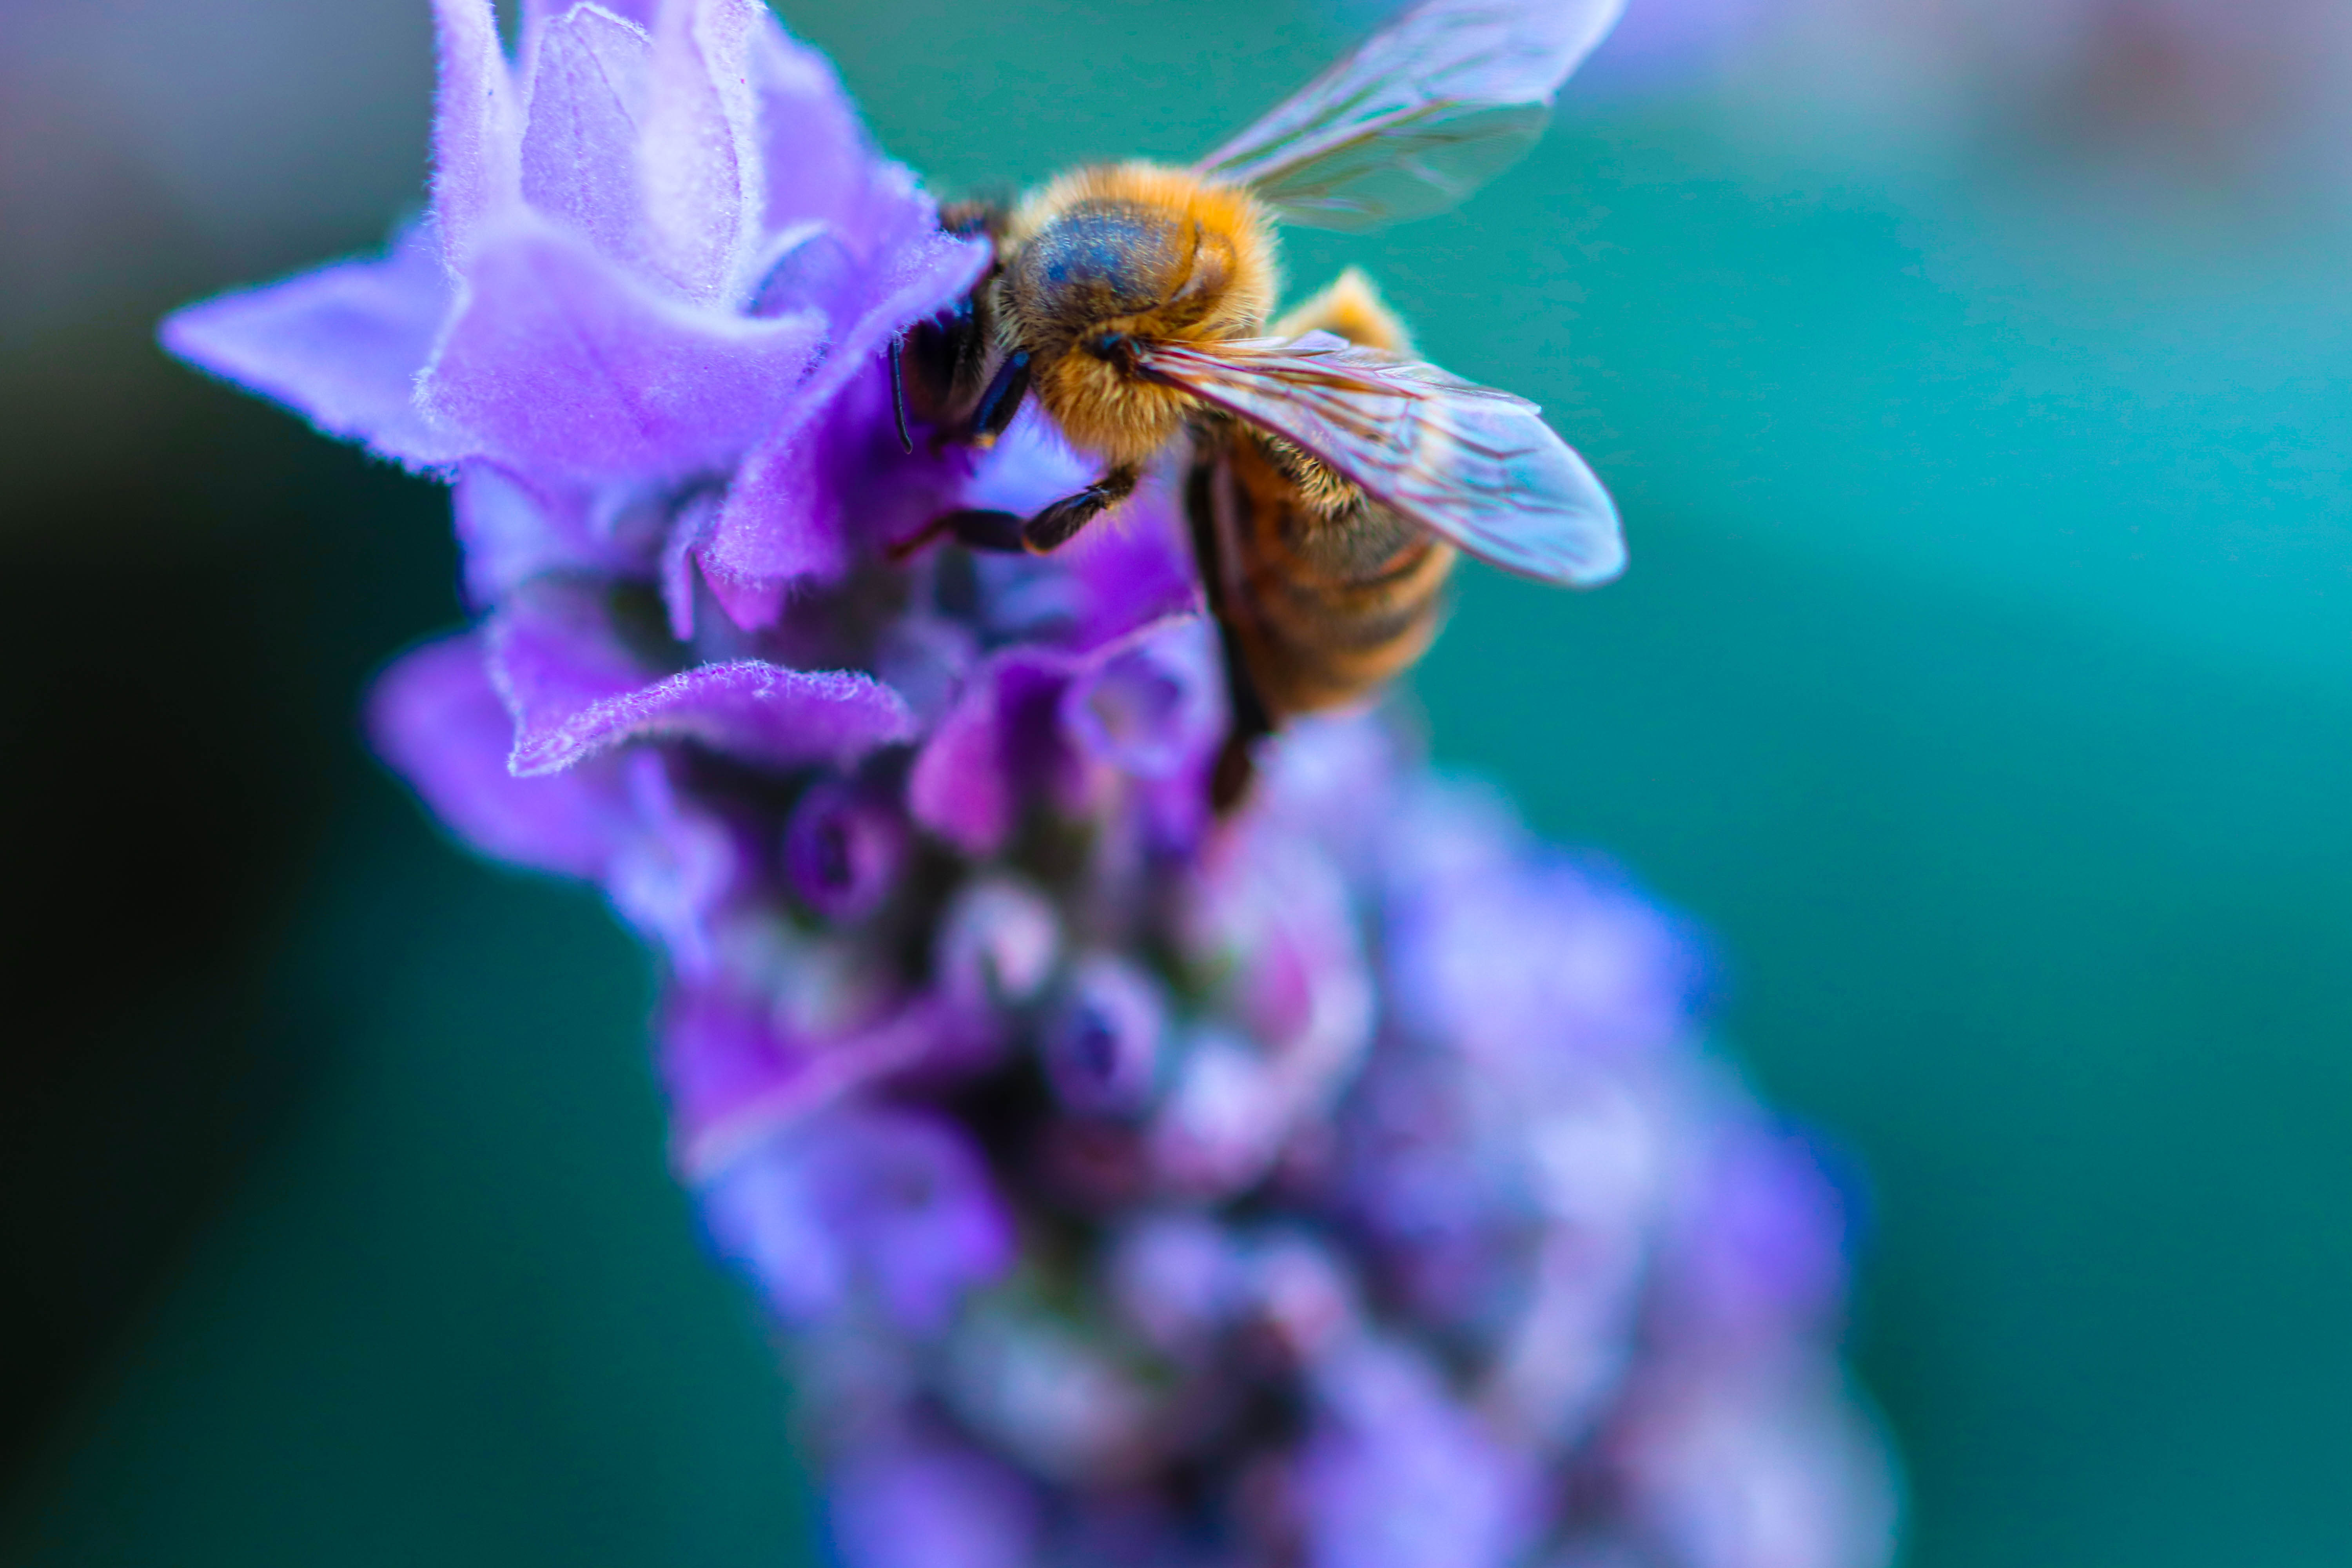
1136;332;1625;588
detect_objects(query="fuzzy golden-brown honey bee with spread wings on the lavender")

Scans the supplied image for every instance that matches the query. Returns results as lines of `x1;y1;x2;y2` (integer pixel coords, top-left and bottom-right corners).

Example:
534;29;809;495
891;0;1625;806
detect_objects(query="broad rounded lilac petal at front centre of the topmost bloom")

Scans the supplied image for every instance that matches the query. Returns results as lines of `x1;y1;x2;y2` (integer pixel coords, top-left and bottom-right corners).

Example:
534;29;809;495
421;223;823;479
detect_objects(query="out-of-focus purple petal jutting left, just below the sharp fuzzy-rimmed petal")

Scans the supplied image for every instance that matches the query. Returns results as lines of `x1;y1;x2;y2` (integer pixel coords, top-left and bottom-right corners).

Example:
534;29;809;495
369;632;630;877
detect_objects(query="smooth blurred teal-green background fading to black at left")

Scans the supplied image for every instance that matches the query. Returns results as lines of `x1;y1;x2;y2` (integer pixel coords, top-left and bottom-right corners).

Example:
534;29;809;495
0;0;2352;1568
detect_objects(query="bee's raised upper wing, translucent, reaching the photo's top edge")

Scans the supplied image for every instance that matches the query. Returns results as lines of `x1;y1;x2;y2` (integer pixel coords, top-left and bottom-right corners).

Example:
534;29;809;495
1195;0;1625;228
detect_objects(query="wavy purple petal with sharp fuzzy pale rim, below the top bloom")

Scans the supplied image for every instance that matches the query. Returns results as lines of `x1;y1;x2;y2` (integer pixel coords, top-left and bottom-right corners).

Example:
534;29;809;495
487;583;913;778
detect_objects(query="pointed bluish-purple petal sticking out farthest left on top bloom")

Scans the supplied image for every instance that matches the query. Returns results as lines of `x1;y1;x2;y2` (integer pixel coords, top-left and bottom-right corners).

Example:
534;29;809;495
162;228;463;468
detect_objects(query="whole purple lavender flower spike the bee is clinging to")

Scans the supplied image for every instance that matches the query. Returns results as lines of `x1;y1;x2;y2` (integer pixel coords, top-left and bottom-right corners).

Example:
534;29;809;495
165;0;1889;1568
